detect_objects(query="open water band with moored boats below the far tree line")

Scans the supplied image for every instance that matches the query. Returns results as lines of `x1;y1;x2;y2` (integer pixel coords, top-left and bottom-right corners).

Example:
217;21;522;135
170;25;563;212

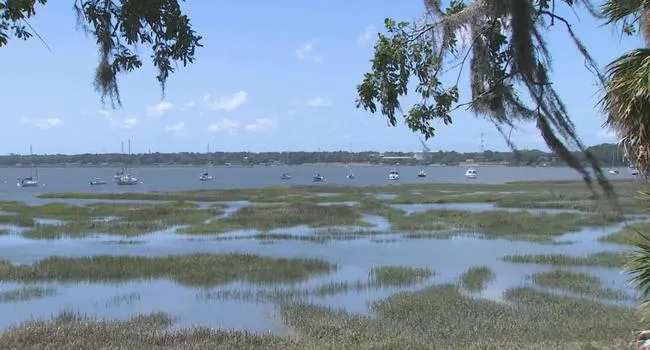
0;164;632;201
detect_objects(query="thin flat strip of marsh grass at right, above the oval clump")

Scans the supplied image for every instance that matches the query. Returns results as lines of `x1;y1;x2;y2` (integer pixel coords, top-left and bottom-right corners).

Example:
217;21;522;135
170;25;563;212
500;252;628;268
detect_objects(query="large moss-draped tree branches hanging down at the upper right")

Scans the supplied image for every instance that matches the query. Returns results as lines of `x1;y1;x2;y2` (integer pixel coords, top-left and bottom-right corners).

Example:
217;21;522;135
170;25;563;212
357;0;650;200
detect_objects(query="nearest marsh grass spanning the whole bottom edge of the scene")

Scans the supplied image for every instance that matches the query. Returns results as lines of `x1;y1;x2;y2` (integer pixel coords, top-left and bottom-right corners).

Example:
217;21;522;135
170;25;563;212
0;285;640;350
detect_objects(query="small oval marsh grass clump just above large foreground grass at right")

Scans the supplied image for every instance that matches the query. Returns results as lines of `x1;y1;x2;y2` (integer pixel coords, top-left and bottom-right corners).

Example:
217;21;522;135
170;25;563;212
531;270;631;300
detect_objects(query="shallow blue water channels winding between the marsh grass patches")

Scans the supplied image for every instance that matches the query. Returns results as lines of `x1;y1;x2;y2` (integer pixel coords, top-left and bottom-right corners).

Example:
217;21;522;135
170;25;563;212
0;185;634;332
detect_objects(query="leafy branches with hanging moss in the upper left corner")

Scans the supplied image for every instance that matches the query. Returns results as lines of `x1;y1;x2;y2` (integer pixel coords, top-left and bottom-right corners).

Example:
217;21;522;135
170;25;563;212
0;0;202;107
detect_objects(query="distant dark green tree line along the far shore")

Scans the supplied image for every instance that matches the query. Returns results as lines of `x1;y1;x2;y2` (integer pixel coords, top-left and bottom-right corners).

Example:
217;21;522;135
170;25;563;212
0;144;625;167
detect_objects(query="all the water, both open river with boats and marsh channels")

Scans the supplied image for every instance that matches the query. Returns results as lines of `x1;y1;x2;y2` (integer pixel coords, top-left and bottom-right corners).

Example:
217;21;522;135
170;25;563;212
0;166;634;332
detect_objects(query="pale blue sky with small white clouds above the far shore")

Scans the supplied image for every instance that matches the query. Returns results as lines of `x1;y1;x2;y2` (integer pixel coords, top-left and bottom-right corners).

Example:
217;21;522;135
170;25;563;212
0;0;641;154
